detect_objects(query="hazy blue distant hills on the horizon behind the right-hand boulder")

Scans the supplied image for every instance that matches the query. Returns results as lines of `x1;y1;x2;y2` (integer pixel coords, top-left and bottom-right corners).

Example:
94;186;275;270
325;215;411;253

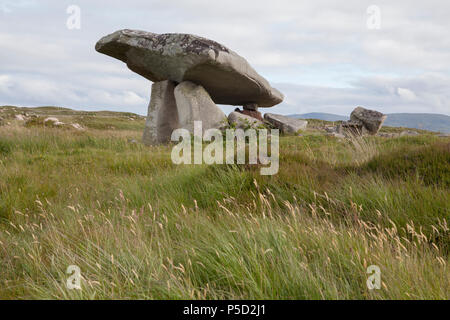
289;112;450;133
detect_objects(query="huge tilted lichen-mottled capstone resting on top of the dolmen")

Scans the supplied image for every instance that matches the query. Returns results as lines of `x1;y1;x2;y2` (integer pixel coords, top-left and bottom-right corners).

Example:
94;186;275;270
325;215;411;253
95;30;283;107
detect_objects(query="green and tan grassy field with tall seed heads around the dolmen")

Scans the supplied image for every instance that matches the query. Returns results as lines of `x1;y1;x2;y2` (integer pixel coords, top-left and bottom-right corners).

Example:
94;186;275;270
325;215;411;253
0;108;450;299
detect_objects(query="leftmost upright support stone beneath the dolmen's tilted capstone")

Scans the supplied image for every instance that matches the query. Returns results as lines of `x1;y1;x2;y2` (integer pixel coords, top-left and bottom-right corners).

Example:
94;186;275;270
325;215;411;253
142;80;179;145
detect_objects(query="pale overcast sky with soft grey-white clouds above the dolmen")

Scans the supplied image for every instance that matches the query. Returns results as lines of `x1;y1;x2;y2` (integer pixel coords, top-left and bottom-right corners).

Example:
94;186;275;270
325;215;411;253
0;0;450;115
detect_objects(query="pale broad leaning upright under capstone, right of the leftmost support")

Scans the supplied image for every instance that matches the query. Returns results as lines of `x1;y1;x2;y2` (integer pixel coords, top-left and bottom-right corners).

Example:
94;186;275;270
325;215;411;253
175;81;227;134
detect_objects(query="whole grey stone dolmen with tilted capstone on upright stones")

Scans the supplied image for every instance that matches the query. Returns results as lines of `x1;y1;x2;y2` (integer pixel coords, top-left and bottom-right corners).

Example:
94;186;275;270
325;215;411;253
95;29;284;145
